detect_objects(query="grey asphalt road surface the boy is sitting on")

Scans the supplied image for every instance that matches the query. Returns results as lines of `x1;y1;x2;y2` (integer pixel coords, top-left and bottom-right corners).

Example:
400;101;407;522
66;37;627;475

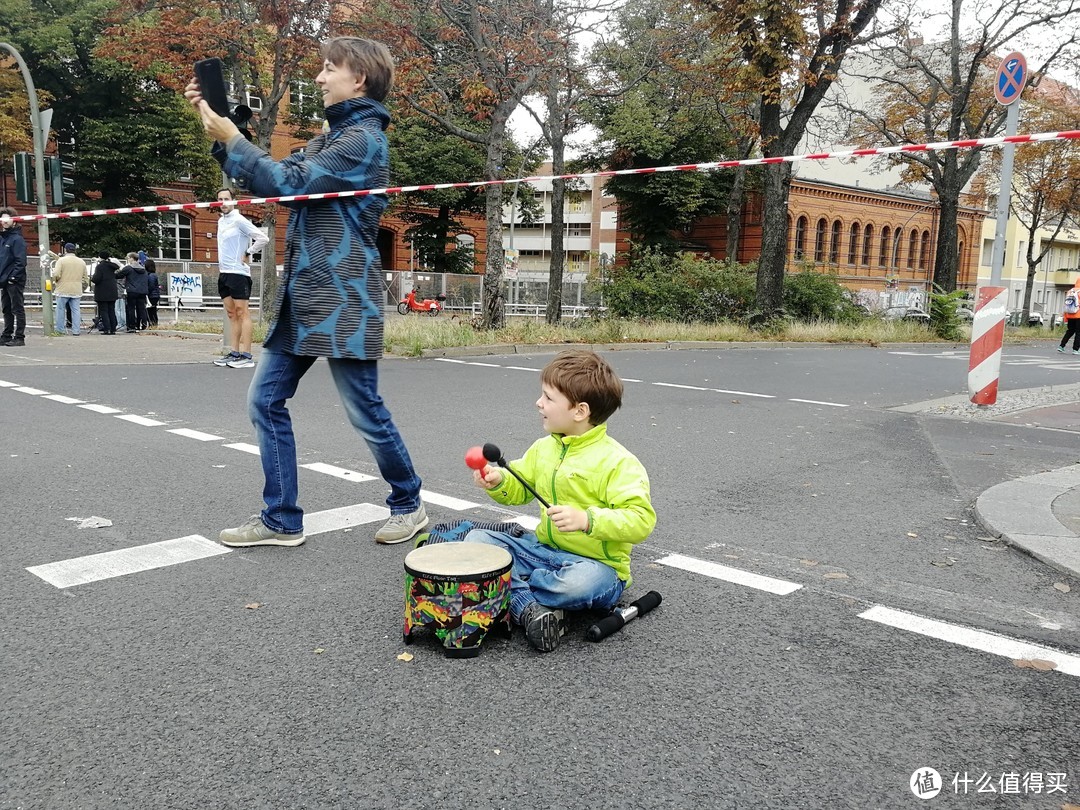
0;338;1080;809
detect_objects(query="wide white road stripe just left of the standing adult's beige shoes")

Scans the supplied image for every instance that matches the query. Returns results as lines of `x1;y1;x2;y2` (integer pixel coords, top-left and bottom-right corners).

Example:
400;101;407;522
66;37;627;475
26;535;229;588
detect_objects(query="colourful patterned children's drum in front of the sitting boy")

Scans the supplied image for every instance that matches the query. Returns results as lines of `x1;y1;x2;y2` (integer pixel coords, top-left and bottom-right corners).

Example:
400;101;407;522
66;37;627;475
403;543;513;658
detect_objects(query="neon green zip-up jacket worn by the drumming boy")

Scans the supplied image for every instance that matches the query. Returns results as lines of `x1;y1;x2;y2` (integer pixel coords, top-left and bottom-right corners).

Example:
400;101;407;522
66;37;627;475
487;423;657;584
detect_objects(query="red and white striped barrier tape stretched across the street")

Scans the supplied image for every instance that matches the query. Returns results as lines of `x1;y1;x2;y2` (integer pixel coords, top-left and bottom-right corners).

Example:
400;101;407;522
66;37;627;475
15;130;1080;222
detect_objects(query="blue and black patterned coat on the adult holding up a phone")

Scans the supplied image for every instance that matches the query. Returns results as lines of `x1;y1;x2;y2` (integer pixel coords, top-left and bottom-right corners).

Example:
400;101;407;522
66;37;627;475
216;98;390;360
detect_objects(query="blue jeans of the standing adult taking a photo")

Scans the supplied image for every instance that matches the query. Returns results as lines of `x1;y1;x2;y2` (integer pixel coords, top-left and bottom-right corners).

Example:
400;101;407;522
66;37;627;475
247;349;420;535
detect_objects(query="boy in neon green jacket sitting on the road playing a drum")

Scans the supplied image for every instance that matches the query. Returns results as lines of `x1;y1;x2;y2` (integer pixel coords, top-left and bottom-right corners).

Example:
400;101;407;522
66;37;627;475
462;350;657;652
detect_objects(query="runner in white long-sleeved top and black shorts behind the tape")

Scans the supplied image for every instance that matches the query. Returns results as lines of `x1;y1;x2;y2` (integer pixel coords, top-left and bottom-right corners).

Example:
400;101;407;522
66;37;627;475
214;188;270;368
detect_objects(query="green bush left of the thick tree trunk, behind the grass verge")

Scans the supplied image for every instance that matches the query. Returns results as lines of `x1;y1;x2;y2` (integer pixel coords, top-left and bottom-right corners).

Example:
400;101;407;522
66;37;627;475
607;249;756;323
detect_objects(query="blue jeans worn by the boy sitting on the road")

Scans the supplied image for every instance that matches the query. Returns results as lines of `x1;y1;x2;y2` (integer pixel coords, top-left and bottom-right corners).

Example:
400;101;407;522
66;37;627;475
462;529;626;624
